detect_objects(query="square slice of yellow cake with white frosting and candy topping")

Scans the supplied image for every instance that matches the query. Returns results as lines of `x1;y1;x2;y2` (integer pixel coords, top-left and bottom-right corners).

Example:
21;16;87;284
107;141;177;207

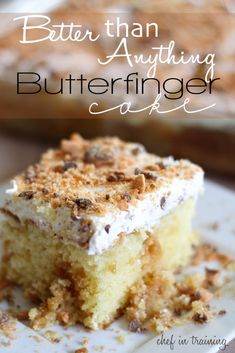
1;135;203;329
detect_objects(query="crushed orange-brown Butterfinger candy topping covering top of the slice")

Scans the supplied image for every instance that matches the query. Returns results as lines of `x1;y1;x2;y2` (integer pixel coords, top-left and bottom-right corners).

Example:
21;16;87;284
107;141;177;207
6;134;201;217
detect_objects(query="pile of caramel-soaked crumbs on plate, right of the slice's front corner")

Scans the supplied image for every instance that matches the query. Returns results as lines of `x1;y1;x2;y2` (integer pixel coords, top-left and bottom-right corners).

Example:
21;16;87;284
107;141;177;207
125;270;222;334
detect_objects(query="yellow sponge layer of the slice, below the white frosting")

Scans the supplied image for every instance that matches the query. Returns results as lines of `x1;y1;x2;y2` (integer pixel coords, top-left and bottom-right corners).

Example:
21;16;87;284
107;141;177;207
1;199;197;329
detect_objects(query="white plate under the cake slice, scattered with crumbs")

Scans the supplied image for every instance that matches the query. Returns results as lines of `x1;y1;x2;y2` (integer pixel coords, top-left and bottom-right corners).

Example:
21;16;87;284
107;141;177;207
0;181;235;353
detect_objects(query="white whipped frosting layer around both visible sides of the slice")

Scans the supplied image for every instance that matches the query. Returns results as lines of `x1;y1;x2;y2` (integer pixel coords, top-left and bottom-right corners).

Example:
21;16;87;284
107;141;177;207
3;166;203;255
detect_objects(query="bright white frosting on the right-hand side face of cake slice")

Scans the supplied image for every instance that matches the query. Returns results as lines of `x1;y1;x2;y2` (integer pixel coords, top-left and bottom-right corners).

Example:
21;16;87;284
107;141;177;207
88;168;203;255
